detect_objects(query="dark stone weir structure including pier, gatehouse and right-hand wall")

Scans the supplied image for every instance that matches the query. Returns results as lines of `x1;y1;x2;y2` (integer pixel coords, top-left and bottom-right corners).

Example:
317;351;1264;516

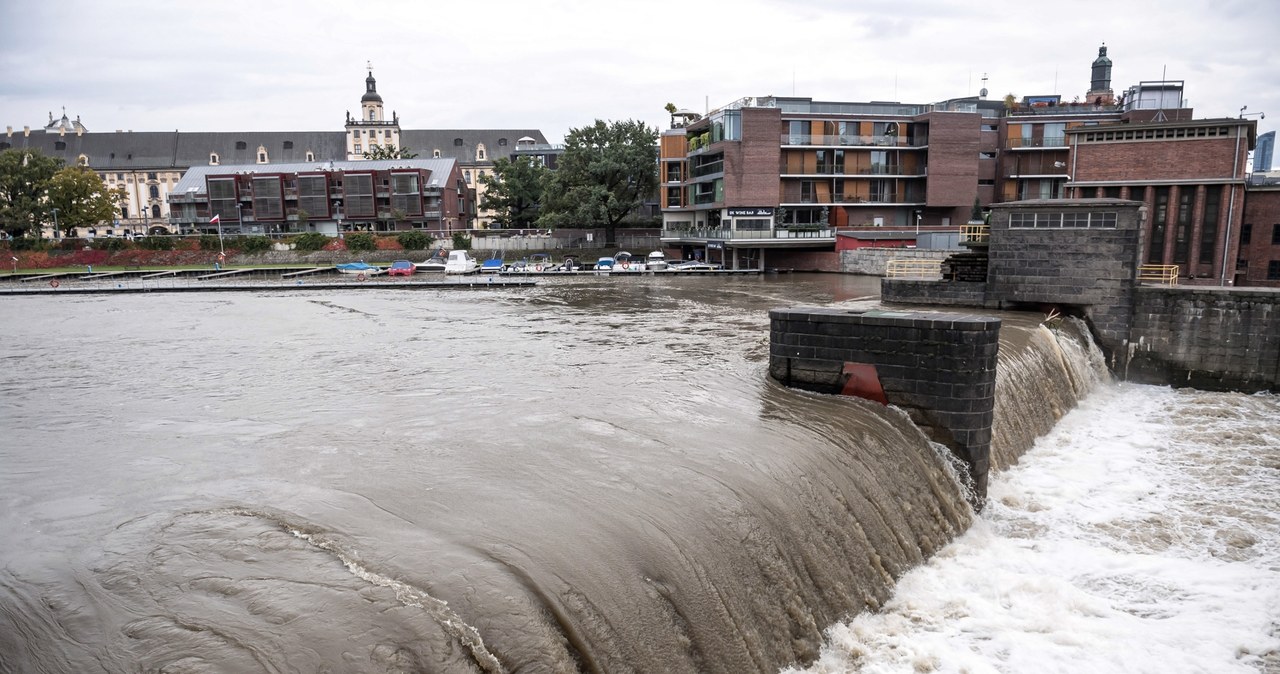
769;198;1280;506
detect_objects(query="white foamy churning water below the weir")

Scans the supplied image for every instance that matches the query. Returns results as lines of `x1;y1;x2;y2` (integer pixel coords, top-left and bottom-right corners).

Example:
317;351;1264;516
787;385;1280;674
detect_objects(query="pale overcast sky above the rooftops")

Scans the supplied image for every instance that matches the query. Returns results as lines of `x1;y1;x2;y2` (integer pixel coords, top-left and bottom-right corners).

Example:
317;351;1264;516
0;0;1280;152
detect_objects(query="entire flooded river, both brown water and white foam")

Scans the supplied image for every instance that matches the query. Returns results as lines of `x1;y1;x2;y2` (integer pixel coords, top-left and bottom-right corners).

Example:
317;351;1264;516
0;275;1280;673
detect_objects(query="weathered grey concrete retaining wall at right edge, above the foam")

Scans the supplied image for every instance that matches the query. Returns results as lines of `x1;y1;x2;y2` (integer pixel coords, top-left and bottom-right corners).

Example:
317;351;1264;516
1120;286;1280;393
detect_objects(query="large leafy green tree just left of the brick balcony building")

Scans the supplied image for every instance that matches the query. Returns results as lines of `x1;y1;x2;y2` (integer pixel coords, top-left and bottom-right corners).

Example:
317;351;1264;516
538;120;658;247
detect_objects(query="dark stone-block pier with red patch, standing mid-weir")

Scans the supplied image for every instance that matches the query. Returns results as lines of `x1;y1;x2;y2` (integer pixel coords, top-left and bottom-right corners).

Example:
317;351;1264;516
769;307;1000;499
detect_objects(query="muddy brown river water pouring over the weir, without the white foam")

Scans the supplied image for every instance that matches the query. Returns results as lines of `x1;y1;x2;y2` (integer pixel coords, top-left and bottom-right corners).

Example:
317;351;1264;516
0;276;1121;673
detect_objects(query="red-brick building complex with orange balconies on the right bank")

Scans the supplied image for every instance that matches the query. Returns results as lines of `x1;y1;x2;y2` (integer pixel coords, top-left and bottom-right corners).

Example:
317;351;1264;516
659;46;1256;285
